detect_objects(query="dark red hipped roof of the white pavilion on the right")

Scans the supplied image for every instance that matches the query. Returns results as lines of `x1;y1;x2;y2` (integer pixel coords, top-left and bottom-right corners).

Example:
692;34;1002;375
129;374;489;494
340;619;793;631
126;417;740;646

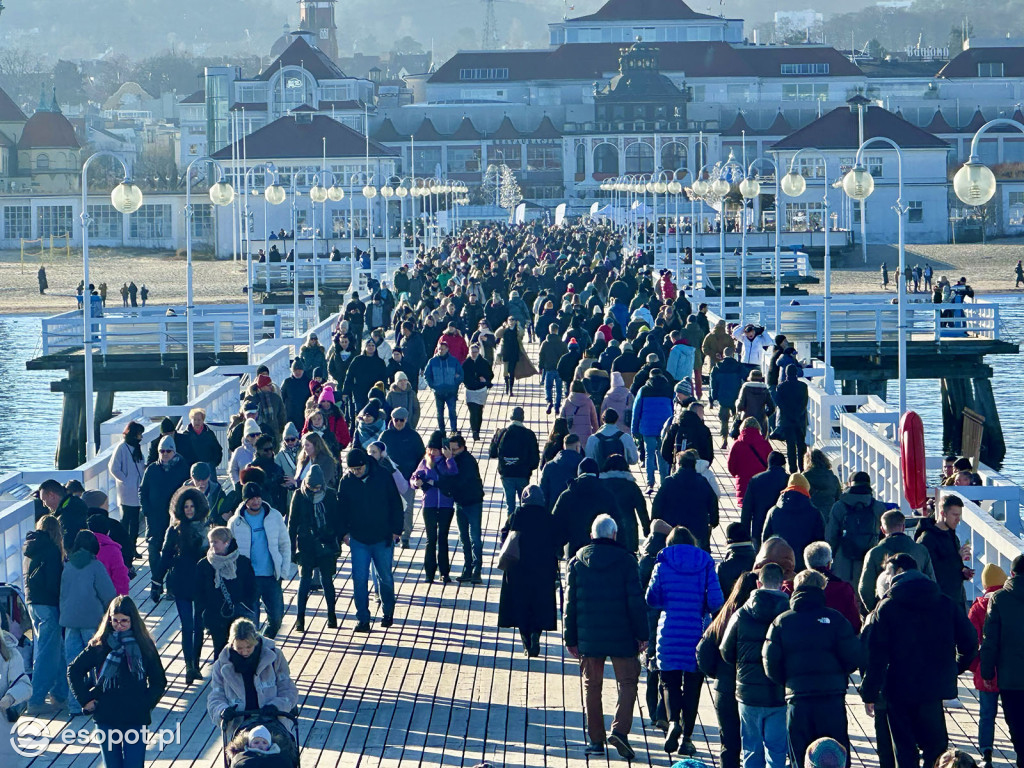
771;106;948;150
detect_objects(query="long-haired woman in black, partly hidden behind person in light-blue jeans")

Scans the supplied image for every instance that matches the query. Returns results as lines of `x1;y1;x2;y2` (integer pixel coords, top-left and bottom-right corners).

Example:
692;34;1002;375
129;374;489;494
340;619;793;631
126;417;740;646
697;571;758;768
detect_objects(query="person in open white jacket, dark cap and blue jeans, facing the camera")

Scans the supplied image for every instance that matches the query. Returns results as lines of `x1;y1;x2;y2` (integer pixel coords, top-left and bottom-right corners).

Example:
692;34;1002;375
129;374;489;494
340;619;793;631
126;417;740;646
227;482;292;639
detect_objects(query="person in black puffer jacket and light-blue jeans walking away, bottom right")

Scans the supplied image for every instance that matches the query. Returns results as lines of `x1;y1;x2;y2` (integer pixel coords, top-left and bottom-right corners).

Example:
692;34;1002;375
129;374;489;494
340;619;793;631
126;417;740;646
721;563;790;765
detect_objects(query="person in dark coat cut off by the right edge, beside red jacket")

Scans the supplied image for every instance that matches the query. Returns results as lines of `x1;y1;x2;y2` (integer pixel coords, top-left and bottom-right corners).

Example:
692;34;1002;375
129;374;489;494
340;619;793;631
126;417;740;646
979;555;1024;764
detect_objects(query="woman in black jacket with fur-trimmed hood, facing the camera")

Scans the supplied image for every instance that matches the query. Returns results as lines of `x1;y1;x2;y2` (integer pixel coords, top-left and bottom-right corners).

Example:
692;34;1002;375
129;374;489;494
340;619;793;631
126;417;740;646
153;487;210;685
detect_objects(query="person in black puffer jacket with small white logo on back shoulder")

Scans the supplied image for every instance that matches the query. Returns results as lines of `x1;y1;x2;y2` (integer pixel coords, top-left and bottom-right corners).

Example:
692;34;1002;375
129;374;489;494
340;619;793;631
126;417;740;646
764;570;860;765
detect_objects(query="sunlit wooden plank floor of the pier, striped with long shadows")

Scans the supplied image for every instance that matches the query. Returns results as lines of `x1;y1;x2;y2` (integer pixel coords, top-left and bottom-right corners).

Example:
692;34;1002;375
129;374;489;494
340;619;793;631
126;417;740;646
25;345;1013;768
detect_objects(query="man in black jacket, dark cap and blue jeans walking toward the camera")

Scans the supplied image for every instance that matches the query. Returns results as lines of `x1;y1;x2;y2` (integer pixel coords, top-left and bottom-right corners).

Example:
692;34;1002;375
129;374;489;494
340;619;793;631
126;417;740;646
338;449;403;632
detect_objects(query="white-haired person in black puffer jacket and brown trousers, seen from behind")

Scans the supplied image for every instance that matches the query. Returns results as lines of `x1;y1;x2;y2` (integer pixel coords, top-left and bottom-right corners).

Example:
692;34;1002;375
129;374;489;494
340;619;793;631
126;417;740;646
562;514;649;759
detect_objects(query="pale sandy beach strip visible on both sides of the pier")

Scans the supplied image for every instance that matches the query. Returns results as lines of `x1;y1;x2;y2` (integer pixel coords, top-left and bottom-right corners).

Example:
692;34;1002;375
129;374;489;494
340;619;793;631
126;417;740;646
0;239;1024;314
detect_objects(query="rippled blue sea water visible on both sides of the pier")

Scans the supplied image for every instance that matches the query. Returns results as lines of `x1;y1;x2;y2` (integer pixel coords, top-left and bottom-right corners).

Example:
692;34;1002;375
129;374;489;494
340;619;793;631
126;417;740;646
0;296;1024;475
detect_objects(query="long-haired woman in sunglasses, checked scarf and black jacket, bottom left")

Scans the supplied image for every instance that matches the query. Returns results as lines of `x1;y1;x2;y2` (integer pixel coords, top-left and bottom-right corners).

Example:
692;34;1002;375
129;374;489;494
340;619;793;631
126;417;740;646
68;595;167;768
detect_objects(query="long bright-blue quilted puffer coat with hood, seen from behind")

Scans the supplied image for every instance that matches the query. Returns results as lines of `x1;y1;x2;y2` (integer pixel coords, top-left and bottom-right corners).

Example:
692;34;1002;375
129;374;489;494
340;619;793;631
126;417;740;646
647;544;724;672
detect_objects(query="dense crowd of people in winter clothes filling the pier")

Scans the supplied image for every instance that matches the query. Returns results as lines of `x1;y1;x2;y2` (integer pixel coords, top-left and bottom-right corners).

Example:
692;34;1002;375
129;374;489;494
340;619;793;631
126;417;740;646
0;225;1024;768
